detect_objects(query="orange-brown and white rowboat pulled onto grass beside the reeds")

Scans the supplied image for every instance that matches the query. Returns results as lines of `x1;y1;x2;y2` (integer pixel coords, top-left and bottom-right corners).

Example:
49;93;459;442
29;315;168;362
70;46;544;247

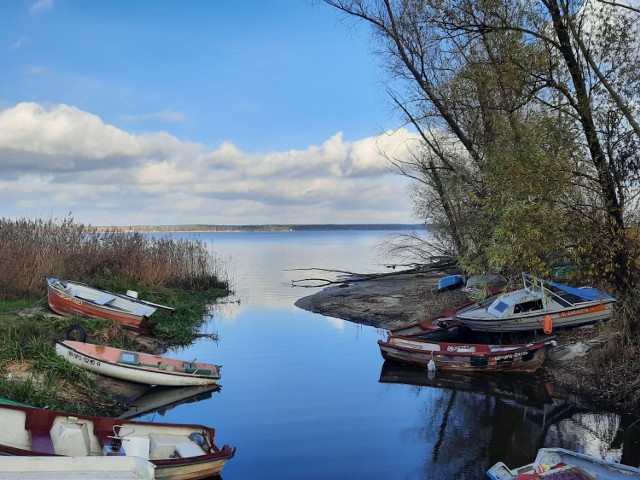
47;277;175;334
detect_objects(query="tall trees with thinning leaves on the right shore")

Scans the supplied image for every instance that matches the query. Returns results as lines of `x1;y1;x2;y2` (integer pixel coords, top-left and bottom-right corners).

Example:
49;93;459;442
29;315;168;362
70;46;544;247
324;0;640;289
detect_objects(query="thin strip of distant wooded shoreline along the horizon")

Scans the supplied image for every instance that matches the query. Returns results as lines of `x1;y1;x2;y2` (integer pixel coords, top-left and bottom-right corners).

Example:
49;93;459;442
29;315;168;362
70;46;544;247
95;223;425;233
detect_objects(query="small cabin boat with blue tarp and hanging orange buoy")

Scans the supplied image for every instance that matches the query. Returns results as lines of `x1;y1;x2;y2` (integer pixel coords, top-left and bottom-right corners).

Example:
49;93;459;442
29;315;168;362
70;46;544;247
455;274;615;333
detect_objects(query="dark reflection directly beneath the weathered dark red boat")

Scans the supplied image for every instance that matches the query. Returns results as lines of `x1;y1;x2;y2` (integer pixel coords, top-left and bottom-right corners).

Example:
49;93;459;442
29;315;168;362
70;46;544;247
380;361;560;406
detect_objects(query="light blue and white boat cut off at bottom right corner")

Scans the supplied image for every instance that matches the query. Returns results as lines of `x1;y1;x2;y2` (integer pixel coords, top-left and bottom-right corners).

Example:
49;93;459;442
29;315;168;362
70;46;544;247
487;448;640;480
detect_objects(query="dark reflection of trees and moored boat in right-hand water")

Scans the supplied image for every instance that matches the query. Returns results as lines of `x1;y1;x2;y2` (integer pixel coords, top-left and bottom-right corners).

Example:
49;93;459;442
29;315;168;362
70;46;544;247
380;362;640;480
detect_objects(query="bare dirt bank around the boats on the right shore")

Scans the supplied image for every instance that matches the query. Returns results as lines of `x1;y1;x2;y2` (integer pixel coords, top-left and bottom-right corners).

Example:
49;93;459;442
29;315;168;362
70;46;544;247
295;272;620;401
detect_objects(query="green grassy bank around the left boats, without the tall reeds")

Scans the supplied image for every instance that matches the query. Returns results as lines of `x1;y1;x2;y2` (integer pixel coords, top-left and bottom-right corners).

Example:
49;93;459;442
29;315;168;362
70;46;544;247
0;282;228;415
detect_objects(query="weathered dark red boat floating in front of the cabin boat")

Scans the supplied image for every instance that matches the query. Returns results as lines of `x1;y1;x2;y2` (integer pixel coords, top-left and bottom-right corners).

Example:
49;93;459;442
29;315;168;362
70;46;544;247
378;336;553;373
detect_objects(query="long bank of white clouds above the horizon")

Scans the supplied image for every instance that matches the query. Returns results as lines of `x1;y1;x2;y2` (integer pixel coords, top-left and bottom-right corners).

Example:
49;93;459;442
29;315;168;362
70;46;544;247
0;103;414;225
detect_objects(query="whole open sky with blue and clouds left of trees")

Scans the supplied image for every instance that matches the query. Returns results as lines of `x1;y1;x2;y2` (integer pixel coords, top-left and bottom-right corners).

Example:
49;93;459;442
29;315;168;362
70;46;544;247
0;0;416;225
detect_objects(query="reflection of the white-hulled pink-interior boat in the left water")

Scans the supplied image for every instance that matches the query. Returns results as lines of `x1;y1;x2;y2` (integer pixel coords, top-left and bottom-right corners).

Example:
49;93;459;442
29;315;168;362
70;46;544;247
118;385;220;418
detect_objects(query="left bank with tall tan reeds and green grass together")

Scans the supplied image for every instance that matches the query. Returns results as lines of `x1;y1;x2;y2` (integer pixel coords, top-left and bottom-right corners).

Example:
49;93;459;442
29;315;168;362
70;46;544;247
0;216;229;413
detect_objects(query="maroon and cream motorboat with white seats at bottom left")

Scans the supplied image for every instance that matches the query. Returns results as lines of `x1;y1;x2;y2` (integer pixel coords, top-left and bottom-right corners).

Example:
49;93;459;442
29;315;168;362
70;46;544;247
0;405;235;480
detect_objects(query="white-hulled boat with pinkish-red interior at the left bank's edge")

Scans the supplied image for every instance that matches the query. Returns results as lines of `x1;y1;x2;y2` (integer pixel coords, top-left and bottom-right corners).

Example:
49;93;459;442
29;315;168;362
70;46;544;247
56;340;220;387
